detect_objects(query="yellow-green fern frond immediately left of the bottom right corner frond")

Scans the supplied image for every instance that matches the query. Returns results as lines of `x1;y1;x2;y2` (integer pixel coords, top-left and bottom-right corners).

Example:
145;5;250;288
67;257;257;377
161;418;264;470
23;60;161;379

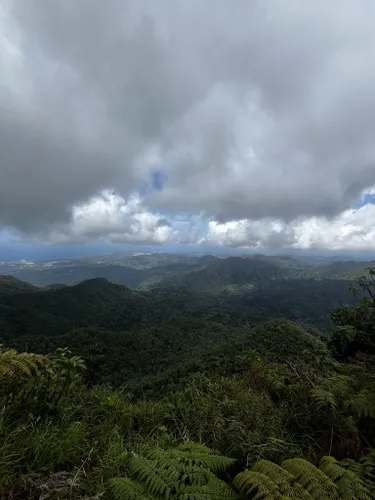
281;458;339;500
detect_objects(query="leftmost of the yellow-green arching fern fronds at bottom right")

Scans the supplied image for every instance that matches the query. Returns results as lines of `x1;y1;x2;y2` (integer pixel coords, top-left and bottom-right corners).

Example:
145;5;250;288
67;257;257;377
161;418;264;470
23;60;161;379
233;470;282;500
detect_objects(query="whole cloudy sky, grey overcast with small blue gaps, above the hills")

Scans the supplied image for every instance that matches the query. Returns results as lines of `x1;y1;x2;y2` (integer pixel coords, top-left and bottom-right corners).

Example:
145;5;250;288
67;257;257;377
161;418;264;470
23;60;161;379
0;0;375;260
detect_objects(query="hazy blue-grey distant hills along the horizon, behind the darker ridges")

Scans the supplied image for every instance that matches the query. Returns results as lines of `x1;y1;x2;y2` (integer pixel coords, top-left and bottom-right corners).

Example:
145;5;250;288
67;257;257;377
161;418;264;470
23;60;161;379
0;254;374;294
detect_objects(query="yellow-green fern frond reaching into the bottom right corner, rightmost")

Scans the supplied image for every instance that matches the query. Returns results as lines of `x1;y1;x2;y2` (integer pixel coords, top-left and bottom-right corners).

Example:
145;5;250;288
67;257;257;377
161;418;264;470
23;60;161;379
319;457;371;500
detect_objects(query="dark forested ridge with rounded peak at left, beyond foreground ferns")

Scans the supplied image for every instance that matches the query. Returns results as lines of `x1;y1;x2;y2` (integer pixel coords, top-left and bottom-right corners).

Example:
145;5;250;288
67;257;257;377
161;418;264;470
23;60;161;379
0;278;158;337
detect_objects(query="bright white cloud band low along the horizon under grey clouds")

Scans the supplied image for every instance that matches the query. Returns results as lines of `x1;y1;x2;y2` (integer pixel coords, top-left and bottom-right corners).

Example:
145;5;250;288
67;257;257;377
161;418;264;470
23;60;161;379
5;184;375;251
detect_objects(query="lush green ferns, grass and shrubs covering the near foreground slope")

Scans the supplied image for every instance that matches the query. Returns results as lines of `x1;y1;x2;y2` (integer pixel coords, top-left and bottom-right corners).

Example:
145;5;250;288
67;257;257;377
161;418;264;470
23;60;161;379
0;271;375;499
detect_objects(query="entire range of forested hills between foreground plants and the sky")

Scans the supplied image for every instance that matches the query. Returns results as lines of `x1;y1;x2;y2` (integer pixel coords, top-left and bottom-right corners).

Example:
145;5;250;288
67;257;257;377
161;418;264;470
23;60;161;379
0;254;372;391
